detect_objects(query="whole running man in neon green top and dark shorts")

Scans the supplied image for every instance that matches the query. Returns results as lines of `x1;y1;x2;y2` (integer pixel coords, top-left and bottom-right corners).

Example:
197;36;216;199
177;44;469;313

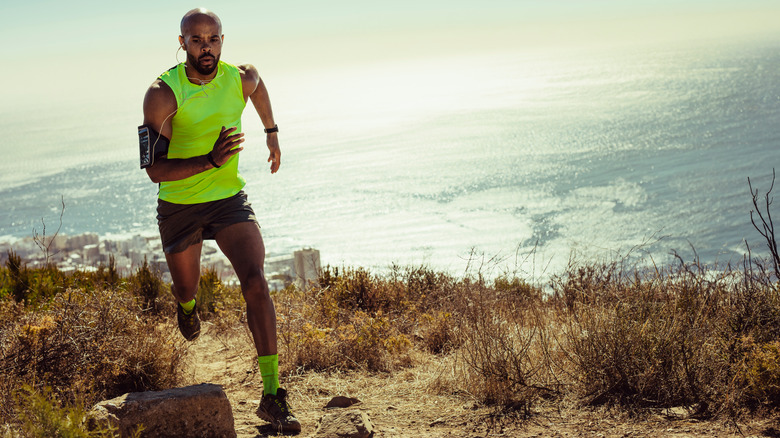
139;9;301;433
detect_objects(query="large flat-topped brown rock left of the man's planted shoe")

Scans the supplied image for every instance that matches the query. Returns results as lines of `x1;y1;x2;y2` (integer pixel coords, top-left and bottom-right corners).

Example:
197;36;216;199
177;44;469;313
89;383;236;438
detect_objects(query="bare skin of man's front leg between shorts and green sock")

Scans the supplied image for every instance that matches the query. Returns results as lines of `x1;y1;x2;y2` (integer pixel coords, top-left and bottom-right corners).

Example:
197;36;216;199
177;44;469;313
215;222;277;357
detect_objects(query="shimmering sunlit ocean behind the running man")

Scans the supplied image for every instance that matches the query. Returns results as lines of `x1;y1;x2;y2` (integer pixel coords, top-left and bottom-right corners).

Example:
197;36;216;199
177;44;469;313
0;36;780;278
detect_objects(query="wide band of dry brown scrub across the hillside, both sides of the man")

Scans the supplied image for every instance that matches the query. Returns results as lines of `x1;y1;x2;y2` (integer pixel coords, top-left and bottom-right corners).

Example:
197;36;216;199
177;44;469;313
0;246;780;434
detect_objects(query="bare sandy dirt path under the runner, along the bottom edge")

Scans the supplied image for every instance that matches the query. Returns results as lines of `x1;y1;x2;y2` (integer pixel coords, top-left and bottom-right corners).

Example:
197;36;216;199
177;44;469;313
184;323;780;438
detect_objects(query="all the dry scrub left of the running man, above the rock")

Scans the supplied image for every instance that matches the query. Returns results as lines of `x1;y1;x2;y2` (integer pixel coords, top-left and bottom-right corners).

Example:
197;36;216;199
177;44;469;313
0;258;184;432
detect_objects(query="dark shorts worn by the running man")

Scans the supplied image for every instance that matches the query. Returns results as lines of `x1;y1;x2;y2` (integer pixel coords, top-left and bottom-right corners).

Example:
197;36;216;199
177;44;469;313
157;190;259;254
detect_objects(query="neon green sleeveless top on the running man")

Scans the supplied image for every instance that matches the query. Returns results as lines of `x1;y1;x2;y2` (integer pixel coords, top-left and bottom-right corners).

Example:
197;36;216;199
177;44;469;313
159;61;246;204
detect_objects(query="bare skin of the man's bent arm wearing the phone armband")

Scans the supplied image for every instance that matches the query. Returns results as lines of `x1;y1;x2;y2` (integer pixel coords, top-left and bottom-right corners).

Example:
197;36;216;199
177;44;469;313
144;79;244;183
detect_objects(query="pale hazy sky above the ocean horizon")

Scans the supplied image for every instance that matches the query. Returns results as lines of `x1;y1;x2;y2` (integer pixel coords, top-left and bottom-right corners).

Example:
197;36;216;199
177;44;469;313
0;0;780;112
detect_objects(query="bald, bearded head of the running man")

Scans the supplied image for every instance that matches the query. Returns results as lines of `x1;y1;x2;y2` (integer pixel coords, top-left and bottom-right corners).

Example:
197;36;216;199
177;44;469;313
179;16;224;76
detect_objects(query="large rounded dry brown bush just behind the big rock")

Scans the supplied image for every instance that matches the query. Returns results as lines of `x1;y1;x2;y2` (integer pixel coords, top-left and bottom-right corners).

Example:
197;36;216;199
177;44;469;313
0;290;183;421
